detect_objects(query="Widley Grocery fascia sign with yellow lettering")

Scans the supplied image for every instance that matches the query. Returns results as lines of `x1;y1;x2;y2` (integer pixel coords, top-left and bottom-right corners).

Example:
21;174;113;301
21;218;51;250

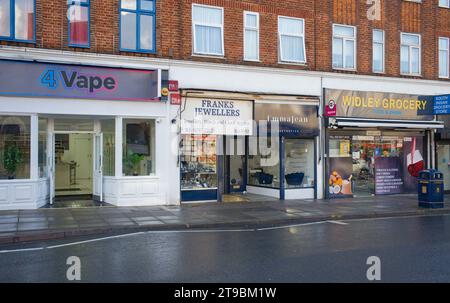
324;89;434;121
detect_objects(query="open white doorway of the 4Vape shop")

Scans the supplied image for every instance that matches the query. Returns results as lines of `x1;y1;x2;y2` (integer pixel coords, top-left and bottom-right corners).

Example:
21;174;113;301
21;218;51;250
49;132;103;205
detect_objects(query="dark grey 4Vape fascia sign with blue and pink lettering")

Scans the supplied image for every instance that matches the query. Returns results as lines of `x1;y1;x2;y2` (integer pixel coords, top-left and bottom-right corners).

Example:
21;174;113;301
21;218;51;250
0;60;158;101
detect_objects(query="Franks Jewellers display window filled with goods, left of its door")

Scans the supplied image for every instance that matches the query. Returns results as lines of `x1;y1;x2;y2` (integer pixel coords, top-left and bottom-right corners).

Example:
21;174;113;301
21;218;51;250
181;135;217;190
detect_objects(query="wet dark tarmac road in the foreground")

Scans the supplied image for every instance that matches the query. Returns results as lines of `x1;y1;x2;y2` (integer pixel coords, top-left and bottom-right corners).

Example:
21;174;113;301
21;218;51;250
0;215;450;283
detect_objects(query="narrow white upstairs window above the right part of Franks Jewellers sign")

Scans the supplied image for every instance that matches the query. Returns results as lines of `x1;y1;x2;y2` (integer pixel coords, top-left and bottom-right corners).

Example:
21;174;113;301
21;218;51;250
244;12;259;61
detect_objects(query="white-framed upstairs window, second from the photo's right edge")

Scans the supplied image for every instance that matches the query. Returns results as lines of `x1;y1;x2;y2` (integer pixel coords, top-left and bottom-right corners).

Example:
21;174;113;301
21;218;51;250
400;33;421;75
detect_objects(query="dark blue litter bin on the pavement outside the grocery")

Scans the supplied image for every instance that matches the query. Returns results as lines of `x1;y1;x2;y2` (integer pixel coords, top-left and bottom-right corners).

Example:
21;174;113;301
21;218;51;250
418;169;444;208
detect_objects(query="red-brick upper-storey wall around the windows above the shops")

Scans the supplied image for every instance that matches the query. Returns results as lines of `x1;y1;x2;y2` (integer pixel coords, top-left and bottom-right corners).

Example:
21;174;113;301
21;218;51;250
0;0;450;81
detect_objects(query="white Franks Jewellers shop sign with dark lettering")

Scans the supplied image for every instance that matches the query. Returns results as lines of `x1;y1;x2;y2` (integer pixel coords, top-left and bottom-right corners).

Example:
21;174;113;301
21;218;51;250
181;98;253;136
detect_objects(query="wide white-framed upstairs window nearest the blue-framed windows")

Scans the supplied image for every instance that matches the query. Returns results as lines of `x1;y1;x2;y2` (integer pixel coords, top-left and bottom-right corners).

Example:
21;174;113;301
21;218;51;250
192;4;224;56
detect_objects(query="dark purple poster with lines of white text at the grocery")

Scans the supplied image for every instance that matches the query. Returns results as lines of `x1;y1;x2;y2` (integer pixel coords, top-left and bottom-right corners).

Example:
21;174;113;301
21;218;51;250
375;157;404;195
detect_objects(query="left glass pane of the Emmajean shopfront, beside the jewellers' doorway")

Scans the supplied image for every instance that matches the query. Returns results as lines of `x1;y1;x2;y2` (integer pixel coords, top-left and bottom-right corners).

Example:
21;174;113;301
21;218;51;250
248;136;280;189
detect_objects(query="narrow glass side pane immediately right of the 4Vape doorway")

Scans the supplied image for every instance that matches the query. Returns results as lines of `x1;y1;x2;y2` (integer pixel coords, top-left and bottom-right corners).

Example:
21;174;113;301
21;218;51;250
101;119;116;176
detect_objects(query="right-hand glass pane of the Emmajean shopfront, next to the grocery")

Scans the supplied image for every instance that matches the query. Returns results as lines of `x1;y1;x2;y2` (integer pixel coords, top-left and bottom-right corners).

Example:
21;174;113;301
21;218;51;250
284;139;314;189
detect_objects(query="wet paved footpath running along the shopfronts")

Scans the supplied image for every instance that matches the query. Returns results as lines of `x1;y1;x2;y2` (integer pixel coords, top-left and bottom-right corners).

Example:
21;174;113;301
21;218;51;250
0;195;450;244
